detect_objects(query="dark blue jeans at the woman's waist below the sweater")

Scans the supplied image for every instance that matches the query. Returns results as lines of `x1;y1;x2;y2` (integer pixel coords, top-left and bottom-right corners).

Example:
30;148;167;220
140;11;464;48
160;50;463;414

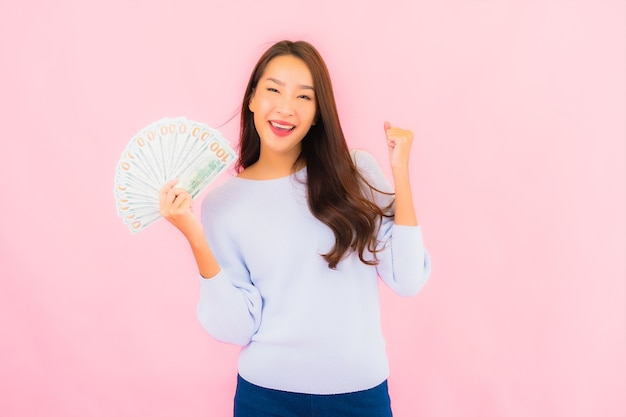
234;376;392;417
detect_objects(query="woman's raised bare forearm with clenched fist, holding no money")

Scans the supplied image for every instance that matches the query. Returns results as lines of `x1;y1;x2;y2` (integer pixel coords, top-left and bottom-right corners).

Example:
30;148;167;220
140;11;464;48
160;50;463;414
384;122;419;226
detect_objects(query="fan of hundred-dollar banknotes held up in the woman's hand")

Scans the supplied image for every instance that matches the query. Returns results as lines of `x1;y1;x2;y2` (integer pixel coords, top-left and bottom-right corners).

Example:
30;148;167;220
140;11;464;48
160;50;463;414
114;117;235;233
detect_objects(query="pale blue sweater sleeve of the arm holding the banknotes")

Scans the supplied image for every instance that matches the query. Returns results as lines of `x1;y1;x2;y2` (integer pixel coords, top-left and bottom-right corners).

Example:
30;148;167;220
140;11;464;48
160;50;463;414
197;191;262;346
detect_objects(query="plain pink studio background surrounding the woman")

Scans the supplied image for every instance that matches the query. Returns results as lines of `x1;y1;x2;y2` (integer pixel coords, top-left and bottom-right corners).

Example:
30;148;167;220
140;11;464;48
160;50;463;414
0;0;626;417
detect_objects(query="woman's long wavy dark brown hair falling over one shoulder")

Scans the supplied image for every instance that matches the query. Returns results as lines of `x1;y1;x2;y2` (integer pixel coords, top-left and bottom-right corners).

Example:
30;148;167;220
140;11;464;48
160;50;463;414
236;41;388;269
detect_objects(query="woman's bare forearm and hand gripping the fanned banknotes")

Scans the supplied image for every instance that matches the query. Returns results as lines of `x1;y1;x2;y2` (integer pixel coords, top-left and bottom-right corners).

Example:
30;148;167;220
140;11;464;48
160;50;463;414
159;180;221;279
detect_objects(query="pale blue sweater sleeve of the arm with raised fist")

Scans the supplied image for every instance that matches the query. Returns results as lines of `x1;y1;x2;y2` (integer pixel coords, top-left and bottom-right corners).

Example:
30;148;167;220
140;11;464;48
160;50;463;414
353;150;431;296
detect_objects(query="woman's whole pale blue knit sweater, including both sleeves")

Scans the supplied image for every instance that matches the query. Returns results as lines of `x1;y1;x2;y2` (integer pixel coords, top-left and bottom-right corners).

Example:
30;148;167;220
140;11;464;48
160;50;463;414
197;151;430;394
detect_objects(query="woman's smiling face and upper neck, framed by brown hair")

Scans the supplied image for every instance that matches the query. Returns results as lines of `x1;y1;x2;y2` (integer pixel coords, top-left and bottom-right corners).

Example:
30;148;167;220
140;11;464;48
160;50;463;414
248;55;317;161
